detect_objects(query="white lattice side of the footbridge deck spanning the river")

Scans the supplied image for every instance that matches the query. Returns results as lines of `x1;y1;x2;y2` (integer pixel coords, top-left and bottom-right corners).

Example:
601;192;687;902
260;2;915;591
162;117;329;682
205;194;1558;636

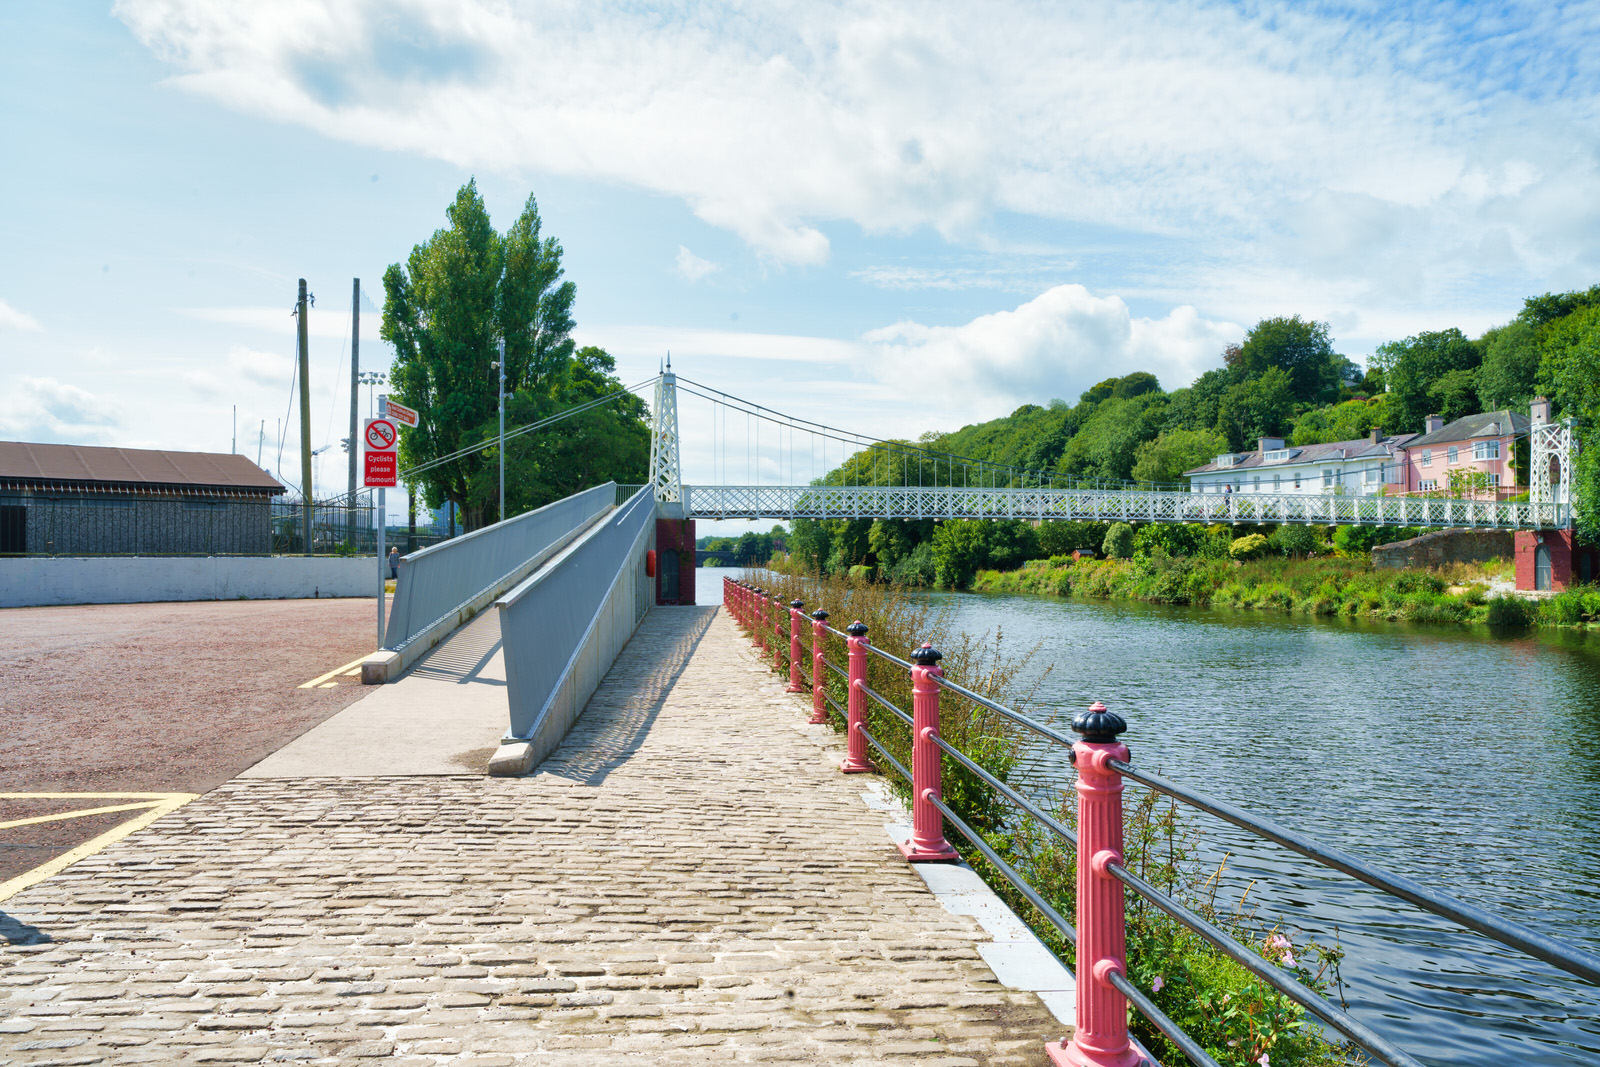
683;485;1566;530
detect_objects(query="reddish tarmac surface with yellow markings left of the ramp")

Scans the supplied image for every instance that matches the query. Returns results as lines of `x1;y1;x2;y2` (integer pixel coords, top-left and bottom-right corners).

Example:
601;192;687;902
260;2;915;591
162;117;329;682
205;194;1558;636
0;600;376;881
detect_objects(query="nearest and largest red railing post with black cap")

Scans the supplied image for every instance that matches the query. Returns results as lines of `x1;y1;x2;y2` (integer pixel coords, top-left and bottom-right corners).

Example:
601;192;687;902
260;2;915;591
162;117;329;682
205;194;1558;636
1046;701;1144;1067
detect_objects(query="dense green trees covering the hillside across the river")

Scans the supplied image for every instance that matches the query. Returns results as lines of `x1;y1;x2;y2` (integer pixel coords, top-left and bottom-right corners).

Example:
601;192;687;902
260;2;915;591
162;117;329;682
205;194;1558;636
789;279;1600;589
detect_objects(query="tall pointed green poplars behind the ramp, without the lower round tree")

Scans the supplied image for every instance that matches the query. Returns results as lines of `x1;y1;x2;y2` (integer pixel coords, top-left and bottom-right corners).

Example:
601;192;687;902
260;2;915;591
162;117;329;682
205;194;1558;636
381;181;592;530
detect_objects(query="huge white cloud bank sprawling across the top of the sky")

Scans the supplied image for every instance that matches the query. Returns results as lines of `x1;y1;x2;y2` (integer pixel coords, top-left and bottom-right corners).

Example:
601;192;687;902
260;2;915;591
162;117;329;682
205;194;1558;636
115;0;1600;299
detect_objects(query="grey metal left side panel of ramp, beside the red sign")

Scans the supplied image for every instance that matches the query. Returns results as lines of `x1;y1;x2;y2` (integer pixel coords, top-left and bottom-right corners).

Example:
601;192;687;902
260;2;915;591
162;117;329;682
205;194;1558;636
384;482;616;649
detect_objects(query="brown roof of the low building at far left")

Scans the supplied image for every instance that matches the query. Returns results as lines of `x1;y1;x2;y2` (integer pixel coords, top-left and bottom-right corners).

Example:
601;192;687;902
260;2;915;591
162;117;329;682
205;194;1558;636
0;442;285;494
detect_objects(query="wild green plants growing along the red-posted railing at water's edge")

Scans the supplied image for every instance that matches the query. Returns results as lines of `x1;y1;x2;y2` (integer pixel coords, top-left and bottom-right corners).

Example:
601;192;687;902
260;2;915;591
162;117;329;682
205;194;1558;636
742;571;1360;1067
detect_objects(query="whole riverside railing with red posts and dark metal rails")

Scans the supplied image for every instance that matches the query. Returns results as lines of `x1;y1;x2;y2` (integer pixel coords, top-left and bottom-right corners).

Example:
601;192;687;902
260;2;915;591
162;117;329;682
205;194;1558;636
723;579;1600;1067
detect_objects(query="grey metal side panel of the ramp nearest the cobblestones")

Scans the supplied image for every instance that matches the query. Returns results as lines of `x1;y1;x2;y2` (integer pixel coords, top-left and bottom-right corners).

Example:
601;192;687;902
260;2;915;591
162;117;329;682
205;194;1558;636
494;486;656;761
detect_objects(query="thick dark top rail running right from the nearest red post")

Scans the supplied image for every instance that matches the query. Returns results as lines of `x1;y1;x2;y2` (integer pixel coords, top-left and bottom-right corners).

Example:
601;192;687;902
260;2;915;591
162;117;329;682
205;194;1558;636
1109;760;1600;984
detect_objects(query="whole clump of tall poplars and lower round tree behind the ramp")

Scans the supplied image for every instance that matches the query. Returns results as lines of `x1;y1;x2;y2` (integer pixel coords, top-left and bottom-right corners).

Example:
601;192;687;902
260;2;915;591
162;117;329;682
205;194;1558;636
381;181;648;530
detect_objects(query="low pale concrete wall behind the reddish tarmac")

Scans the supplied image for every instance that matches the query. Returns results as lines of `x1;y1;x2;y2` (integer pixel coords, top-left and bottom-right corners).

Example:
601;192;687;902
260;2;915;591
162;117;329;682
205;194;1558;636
0;555;378;608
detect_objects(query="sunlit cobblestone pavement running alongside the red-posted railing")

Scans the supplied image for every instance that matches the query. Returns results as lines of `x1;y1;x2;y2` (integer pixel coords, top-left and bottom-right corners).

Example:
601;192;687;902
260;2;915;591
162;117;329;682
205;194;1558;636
0;608;1062;1067
